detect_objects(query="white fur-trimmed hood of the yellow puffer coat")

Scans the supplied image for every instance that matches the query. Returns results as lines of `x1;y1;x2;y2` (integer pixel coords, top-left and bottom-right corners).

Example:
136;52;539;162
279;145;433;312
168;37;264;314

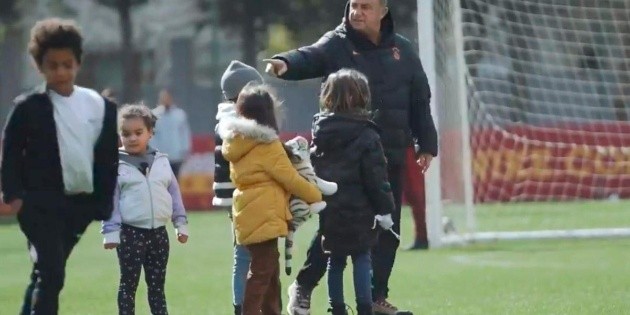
218;117;279;162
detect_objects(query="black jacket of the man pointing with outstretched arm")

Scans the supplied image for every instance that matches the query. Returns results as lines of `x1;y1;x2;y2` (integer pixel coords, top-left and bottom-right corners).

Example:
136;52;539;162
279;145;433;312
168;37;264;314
273;3;438;165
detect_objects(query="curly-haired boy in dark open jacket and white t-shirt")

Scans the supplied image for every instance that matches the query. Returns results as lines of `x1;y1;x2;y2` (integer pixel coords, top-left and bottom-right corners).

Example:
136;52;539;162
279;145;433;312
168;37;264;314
0;18;118;315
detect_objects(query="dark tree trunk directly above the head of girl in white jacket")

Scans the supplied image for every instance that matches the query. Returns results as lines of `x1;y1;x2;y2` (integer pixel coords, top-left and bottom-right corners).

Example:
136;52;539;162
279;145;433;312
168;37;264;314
117;0;140;102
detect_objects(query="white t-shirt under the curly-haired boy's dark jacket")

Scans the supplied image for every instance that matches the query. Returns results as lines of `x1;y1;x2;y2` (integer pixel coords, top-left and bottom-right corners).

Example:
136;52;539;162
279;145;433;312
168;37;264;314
48;85;105;195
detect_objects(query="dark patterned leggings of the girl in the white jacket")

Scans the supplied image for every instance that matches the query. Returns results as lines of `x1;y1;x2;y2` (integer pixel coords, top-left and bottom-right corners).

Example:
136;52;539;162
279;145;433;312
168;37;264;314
117;225;169;315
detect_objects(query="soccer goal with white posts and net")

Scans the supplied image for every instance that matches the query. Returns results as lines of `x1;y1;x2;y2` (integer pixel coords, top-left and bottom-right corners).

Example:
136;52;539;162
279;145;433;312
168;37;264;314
418;0;630;246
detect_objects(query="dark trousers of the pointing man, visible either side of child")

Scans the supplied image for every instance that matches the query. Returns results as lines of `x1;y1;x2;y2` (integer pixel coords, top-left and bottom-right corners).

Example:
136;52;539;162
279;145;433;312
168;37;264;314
296;165;404;300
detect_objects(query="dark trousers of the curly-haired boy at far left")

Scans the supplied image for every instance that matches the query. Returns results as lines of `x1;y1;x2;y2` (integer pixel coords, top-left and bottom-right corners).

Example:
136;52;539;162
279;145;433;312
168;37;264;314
17;195;94;315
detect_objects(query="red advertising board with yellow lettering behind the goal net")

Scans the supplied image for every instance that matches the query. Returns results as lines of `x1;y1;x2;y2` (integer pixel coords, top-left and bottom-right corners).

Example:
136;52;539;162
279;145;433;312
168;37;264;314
470;123;630;202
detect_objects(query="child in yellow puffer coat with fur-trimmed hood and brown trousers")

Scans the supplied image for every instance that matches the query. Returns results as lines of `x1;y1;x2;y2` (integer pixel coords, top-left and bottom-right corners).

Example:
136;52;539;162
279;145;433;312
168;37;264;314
218;84;322;315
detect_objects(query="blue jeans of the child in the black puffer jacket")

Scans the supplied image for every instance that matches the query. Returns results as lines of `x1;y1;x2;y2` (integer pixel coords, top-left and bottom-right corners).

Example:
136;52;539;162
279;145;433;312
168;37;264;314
328;251;372;305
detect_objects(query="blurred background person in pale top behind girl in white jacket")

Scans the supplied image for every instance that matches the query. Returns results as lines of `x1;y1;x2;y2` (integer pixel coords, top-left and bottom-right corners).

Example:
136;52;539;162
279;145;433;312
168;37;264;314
151;89;192;177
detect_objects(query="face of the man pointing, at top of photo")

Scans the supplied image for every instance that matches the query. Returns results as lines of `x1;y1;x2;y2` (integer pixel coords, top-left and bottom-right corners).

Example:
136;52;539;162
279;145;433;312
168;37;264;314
350;0;387;34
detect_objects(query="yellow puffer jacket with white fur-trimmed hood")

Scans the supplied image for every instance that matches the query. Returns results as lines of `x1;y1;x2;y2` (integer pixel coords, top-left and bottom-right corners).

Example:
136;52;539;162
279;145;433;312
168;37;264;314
218;118;322;245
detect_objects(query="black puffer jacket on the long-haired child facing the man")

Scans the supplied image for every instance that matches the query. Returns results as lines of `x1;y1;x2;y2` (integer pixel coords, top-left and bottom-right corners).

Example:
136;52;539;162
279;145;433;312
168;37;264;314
311;113;394;254
